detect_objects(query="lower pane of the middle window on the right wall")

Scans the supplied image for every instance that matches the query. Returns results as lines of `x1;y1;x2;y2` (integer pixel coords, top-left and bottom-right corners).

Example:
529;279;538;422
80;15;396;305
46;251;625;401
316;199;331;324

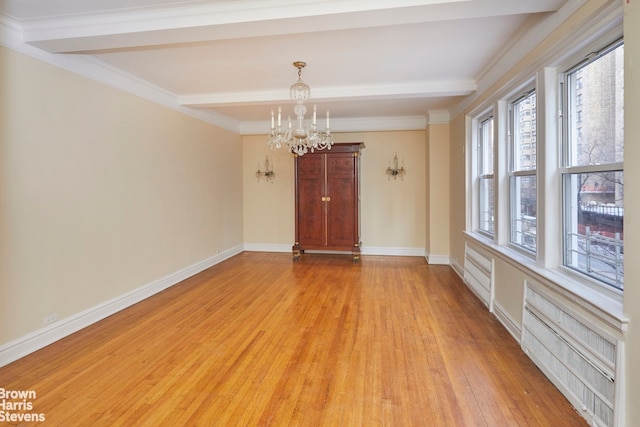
511;175;537;252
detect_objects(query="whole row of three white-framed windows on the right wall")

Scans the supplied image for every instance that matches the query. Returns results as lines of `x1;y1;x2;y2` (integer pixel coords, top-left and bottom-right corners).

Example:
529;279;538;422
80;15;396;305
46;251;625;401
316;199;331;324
467;25;625;308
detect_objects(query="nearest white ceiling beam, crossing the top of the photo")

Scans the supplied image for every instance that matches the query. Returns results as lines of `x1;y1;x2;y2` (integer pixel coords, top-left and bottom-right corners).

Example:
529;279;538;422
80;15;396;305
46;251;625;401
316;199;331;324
21;0;564;53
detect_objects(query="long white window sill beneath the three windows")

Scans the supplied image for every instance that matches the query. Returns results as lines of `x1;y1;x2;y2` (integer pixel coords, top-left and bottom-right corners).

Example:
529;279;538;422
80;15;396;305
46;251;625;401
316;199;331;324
465;232;628;333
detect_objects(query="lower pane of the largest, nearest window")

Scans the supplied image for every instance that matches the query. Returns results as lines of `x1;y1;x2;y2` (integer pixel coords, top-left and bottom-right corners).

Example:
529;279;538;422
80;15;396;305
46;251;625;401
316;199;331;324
564;171;624;289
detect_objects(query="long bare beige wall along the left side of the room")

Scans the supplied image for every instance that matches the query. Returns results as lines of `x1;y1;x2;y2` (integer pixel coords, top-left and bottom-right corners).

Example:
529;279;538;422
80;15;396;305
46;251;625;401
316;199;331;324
0;48;242;345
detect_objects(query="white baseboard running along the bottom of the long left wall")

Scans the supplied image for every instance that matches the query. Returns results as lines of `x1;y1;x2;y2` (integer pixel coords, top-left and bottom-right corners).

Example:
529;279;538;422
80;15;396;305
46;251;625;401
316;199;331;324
0;246;242;366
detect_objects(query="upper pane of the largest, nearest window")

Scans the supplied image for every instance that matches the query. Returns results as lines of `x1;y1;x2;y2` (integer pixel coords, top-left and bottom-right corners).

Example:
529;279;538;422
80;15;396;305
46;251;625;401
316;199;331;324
566;45;624;166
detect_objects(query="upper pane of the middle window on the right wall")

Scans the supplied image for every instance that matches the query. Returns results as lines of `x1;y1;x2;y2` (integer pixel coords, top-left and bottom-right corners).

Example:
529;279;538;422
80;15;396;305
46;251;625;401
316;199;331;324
512;92;536;171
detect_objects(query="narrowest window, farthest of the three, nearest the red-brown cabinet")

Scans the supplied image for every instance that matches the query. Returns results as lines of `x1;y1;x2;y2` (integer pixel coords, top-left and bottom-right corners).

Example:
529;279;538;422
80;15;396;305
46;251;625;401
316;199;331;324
478;117;495;235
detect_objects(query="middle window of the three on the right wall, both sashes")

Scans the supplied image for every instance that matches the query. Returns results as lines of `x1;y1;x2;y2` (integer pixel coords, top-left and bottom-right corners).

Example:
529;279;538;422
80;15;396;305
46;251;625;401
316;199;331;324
509;91;537;253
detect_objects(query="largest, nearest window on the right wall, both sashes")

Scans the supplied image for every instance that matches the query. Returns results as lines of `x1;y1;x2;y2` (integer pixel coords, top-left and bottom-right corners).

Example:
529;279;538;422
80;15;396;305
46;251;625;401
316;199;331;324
561;42;624;290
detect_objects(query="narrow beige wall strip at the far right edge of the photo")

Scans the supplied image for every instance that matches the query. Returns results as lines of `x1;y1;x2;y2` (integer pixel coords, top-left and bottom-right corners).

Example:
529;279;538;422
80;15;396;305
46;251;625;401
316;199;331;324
624;2;640;426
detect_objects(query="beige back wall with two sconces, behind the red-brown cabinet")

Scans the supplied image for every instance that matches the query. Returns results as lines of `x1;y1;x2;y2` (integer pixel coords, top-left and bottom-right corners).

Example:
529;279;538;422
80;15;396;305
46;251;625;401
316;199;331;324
243;130;428;252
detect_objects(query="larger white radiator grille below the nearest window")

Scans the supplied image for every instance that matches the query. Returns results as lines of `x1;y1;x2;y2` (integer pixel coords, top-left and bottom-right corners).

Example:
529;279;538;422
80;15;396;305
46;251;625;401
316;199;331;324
522;286;616;426
